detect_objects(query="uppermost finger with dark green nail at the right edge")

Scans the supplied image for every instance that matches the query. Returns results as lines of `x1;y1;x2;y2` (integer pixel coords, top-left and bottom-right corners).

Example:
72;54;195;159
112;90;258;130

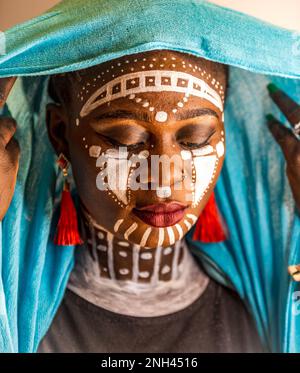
268;83;300;127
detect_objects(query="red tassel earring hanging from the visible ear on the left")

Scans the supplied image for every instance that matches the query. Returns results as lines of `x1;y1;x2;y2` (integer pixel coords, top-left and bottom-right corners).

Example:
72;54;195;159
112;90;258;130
54;153;83;246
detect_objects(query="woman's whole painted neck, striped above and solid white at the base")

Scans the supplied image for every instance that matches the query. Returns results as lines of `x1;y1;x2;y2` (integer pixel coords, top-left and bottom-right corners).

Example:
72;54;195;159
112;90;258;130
68;205;208;317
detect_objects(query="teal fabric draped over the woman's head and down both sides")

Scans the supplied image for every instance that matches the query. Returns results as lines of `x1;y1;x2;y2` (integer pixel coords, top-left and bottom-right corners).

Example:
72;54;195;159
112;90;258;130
0;0;300;352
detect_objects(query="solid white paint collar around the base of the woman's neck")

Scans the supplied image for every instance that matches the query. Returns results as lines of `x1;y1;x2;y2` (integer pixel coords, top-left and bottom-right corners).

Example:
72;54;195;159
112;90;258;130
68;240;209;317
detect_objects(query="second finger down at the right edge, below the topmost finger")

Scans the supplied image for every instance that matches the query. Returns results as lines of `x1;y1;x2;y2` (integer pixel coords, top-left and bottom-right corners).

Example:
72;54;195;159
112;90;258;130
266;114;298;160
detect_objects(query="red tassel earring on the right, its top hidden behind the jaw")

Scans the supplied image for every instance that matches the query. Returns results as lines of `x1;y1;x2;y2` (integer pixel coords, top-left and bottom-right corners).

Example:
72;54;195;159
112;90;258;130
193;193;227;243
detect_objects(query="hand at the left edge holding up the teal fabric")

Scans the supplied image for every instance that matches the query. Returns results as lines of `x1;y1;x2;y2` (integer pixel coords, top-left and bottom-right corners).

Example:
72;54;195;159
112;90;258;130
0;77;20;221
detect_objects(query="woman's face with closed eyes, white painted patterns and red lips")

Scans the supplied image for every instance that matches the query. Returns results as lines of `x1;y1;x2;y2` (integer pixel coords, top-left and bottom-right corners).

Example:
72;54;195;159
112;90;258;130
48;51;226;248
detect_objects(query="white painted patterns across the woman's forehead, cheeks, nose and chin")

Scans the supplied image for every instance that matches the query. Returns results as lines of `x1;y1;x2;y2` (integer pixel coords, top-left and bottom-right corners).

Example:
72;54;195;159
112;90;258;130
79;58;224;246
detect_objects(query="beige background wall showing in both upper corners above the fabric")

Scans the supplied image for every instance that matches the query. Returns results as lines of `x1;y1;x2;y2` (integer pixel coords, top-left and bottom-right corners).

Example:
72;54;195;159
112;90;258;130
0;0;300;31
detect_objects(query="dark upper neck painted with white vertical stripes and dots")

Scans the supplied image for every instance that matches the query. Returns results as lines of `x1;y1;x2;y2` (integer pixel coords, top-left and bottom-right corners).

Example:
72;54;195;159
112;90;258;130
77;208;188;284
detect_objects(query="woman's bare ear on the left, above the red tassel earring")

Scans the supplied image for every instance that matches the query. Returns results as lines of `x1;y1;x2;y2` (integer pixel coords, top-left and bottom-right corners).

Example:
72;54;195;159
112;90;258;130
46;103;70;159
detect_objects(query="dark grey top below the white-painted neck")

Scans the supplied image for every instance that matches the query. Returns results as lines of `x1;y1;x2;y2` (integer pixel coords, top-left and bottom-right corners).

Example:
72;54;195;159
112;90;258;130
38;280;263;353
